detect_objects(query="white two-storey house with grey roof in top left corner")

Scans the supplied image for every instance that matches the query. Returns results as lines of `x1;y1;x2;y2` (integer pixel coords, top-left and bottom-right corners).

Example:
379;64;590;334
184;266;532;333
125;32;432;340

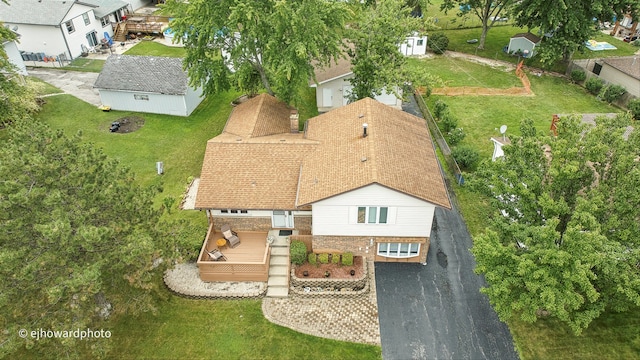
0;0;148;61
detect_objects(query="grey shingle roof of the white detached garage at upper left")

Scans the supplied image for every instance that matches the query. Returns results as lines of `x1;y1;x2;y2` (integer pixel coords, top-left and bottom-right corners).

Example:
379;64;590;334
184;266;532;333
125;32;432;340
94;55;188;95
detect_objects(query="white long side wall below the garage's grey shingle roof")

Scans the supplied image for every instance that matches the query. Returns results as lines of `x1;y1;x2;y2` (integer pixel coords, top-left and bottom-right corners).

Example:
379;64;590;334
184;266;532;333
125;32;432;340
100;89;195;116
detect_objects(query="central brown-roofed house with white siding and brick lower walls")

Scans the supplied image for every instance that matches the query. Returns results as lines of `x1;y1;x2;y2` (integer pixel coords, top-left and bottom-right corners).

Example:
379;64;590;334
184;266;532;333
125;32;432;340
195;94;451;263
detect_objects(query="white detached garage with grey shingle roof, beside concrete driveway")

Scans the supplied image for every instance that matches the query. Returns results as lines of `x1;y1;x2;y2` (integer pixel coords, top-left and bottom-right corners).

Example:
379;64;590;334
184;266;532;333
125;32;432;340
94;55;203;116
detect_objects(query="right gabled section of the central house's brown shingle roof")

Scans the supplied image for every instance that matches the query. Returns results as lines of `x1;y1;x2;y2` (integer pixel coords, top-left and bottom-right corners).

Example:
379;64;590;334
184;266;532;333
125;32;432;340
297;98;451;208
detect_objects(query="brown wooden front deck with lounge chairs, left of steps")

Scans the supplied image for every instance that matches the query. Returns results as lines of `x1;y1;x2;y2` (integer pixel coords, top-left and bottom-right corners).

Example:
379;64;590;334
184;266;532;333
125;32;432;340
197;228;271;281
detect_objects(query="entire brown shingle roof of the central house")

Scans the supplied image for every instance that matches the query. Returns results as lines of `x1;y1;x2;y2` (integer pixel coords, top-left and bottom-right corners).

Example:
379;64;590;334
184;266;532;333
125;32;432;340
195;95;451;210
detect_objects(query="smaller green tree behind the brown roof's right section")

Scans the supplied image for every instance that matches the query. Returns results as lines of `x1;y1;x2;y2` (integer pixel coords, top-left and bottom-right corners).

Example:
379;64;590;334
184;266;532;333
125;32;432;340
347;0;421;100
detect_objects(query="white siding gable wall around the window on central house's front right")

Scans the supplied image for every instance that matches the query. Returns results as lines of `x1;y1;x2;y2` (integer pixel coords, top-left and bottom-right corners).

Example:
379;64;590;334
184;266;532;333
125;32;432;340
312;184;435;237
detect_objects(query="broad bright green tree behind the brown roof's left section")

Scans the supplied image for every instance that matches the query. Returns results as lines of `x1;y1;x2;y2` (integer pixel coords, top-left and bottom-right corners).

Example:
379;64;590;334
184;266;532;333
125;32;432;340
161;0;348;103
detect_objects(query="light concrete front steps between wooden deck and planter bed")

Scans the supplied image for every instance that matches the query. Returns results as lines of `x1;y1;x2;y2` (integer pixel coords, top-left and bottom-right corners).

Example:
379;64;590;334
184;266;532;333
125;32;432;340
267;230;290;297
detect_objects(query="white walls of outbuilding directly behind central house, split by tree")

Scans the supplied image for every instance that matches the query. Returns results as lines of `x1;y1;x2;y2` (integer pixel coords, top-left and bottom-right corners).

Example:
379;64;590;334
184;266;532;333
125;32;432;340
316;74;402;112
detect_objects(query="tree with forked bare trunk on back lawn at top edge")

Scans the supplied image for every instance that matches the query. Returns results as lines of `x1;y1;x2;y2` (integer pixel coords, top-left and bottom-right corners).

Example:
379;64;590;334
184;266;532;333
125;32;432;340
440;0;514;50
